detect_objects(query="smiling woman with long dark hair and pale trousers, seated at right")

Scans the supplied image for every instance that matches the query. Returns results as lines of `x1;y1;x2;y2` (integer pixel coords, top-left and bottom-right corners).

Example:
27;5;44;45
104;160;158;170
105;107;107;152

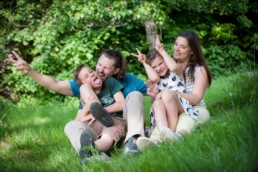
137;31;212;149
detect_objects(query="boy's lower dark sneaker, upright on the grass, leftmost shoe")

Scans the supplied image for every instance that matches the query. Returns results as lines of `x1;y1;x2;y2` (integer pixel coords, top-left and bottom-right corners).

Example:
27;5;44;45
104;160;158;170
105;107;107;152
79;129;95;159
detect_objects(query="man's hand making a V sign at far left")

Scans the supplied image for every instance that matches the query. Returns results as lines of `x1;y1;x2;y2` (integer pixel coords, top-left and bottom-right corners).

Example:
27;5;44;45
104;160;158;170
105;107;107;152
5;51;32;74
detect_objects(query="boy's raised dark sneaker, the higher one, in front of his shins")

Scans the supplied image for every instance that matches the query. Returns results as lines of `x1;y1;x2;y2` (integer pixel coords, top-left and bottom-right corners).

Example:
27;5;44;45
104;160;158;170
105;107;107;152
90;102;113;127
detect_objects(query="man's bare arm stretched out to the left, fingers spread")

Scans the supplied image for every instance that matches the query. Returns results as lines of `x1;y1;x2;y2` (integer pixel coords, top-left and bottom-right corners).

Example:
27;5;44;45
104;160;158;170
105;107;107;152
5;51;72;96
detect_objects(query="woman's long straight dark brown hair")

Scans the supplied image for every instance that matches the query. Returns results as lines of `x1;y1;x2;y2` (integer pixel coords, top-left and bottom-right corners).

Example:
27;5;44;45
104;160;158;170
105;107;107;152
178;31;212;85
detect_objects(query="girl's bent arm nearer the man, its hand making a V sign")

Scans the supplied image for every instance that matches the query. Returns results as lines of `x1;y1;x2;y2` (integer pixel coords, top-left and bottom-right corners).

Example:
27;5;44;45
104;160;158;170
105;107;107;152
131;48;160;83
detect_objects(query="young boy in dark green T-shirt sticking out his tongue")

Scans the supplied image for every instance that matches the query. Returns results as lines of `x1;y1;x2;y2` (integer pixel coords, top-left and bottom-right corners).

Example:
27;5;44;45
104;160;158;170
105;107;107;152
71;64;126;161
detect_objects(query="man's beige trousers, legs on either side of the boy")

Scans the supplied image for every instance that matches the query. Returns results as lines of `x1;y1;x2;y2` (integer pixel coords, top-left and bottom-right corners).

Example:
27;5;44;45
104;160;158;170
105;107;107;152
64;91;145;153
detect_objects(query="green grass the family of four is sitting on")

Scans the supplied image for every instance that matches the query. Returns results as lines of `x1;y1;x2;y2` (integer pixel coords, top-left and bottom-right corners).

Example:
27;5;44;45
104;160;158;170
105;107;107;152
0;71;258;172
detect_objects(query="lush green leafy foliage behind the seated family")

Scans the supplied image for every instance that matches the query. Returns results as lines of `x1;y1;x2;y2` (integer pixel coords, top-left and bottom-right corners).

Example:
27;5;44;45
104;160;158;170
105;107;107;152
0;0;258;98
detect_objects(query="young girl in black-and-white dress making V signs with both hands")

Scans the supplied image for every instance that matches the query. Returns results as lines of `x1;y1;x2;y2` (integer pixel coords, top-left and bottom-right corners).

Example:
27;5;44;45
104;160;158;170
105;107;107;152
132;37;198;148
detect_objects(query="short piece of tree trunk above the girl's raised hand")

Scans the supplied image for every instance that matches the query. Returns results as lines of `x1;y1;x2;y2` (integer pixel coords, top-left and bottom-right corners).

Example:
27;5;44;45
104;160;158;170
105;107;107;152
145;21;157;50
